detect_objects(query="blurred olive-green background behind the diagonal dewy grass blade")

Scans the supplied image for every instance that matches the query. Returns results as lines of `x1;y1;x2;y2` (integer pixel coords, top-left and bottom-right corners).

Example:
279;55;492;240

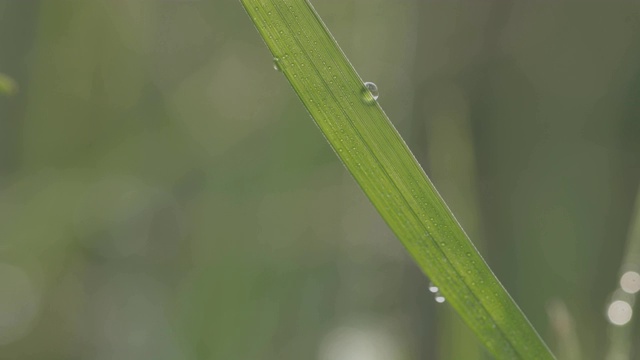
0;0;640;360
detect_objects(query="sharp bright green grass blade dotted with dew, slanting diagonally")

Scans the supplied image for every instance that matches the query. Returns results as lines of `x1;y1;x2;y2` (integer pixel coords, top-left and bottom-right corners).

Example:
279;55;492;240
241;0;553;359
